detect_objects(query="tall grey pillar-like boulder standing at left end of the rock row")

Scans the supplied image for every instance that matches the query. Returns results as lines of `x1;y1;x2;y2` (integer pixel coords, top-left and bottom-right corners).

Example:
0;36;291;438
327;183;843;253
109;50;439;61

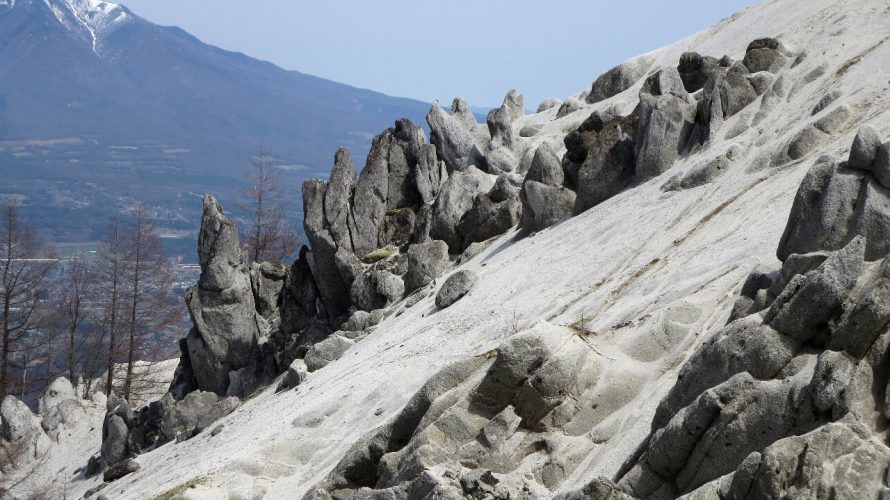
186;196;259;394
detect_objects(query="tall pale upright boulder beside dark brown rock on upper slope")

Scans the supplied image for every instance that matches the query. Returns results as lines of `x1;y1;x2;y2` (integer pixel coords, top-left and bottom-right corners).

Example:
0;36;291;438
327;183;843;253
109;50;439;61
634;68;696;182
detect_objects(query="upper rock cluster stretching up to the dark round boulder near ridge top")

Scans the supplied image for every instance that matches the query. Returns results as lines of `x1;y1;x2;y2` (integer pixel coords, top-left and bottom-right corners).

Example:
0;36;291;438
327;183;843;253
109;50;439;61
520;39;792;235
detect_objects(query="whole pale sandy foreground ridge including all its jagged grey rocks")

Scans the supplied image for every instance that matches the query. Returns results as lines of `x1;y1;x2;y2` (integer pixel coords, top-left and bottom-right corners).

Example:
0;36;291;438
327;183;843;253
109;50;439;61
4;0;890;500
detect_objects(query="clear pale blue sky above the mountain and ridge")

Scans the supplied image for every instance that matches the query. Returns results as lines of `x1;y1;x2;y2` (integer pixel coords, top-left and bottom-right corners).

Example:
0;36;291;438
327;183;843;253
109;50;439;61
123;0;756;108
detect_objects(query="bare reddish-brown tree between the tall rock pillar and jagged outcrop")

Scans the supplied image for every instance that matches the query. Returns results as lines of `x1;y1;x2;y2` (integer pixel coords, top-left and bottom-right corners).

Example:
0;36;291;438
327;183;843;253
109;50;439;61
238;148;299;262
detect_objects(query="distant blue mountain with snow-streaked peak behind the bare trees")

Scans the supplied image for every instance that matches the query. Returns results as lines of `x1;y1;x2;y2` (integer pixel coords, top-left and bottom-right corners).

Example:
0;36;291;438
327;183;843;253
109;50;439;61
0;0;428;257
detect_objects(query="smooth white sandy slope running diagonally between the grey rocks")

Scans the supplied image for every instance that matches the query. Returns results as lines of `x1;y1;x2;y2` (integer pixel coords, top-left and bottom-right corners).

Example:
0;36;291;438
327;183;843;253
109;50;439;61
19;0;890;499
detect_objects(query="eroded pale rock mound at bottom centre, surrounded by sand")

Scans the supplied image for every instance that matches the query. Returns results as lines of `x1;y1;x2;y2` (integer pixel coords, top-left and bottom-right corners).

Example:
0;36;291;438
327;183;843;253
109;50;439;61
305;323;612;498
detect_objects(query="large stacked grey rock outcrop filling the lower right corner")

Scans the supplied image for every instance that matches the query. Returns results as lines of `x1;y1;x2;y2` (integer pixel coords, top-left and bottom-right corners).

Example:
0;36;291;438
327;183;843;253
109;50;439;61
560;131;890;498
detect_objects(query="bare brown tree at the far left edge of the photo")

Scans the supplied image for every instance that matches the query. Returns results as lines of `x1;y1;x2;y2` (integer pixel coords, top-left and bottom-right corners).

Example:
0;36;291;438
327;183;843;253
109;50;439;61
0;199;54;397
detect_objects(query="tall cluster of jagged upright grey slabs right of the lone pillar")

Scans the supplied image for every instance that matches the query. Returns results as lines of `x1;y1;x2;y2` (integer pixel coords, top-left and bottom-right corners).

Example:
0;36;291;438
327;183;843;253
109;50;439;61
303;120;450;316
